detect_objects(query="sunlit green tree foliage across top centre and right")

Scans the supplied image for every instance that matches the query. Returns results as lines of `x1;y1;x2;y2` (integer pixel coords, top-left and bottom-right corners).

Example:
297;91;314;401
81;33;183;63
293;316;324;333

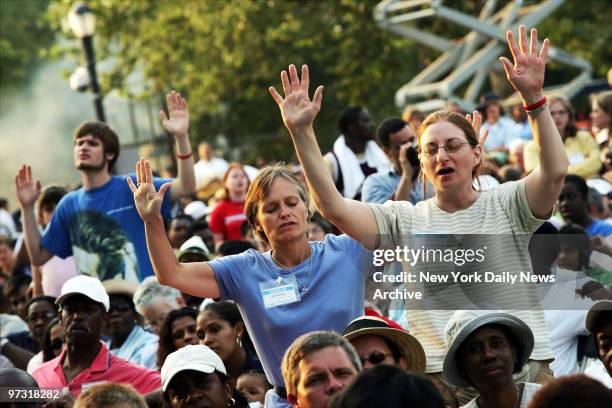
49;0;611;160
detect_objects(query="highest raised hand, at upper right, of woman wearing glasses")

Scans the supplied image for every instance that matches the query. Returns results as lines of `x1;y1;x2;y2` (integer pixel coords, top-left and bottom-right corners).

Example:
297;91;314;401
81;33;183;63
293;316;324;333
499;25;549;105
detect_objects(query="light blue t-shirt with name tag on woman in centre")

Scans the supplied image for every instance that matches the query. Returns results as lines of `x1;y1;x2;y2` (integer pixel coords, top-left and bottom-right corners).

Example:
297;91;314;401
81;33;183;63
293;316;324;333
210;234;372;386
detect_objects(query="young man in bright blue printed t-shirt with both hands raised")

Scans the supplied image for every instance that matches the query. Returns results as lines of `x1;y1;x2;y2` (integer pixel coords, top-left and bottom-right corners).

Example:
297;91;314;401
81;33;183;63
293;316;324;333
15;91;195;283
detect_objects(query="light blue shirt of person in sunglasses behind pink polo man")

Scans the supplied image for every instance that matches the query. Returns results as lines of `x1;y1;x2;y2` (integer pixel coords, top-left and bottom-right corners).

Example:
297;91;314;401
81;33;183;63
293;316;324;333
106;325;159;370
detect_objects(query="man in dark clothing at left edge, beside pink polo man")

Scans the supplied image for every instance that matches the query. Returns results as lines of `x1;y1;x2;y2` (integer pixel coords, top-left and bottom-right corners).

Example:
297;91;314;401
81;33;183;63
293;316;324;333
0;296;57;370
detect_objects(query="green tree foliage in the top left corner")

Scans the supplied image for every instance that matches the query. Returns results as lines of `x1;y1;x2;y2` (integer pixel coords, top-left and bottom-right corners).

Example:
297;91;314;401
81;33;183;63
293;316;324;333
0;0;53;89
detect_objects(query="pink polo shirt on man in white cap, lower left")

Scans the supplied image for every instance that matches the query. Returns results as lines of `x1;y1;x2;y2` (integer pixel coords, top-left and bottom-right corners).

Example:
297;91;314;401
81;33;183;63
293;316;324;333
32;342;161;397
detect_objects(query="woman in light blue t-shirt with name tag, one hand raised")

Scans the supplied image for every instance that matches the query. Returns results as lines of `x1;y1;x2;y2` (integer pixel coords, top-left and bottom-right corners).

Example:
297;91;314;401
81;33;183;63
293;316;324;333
128;159;368;407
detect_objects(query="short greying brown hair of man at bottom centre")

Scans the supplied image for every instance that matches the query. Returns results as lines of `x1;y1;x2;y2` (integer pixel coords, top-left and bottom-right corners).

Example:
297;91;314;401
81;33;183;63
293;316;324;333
281;331;362;395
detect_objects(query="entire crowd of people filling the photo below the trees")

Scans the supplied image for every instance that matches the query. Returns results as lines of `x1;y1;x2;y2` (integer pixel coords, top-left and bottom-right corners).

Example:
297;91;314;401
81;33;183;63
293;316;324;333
0;26;612;408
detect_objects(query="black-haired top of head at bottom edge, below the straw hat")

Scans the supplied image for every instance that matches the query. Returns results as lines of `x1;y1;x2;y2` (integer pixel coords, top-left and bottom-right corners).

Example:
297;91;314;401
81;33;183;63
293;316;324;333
329;364;444;408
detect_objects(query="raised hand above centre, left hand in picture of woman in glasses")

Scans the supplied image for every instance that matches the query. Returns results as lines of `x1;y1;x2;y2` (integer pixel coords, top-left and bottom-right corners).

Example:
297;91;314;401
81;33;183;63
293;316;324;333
268;64;323;132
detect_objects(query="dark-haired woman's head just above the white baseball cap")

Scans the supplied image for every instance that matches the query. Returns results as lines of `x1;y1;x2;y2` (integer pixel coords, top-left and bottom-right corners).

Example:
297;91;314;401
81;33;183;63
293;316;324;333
157;307;198;369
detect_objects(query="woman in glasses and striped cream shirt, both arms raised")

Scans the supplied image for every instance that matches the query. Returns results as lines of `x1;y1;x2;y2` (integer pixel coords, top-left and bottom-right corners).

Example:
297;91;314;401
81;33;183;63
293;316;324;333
269;26;568;404
